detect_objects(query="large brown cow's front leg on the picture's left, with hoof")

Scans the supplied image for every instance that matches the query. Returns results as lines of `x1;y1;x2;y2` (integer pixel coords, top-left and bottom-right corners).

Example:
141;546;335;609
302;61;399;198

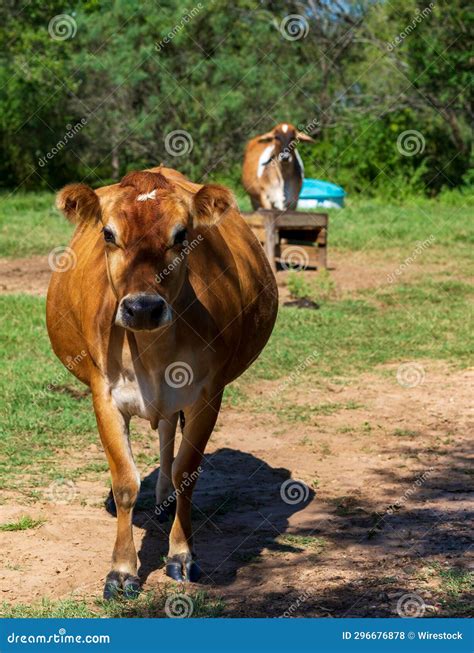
92;384;140;599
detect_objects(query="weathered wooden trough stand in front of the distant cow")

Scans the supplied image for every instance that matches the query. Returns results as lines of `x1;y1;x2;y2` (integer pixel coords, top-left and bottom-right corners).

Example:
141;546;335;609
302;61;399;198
242;209;328;272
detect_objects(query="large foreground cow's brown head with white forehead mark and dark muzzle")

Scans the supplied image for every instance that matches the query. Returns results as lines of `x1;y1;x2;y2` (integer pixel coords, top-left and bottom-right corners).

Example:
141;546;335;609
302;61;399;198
57;172;235;331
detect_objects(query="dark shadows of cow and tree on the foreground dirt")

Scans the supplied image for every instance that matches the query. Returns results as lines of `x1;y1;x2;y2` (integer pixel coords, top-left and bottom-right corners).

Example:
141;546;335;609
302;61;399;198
105;440;472;617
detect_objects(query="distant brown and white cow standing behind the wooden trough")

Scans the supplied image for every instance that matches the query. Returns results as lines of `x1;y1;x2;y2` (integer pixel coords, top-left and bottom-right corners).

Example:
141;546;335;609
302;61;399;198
242;123;314;211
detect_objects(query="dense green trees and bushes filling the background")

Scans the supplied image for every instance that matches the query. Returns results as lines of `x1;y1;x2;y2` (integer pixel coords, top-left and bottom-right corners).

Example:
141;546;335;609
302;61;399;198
0;0;472;197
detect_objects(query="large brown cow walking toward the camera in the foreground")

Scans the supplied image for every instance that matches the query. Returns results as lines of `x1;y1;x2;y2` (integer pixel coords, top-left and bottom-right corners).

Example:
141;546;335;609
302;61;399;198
47;167;278;598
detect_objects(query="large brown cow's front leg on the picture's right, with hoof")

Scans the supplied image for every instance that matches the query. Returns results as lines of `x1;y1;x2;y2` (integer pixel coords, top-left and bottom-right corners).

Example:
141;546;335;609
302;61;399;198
166;391;222;582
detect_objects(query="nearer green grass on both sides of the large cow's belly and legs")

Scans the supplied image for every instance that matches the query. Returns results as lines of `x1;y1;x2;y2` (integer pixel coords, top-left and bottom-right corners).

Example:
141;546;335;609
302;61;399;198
0;277;473;492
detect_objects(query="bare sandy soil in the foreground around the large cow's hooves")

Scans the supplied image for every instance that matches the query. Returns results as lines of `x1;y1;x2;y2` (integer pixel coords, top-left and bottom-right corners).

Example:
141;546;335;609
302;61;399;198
0;361;474;617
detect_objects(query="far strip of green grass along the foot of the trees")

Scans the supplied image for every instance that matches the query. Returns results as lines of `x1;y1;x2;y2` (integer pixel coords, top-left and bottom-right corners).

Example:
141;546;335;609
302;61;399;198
0;190;474;261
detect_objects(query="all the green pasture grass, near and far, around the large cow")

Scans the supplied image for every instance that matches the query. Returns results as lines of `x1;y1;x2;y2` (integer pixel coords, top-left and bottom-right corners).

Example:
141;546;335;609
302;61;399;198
0;193;473;496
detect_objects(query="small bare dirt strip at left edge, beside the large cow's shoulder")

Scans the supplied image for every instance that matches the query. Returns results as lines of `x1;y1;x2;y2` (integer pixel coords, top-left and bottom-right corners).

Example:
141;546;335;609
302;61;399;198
0;256;51;295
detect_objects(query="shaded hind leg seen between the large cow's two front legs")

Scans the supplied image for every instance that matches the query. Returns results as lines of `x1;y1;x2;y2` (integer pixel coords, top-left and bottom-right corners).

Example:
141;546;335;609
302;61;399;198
155;413;178;522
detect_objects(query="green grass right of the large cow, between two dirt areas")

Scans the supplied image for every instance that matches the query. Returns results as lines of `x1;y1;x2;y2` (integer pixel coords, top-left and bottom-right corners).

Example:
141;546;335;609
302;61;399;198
246;276;474;387
